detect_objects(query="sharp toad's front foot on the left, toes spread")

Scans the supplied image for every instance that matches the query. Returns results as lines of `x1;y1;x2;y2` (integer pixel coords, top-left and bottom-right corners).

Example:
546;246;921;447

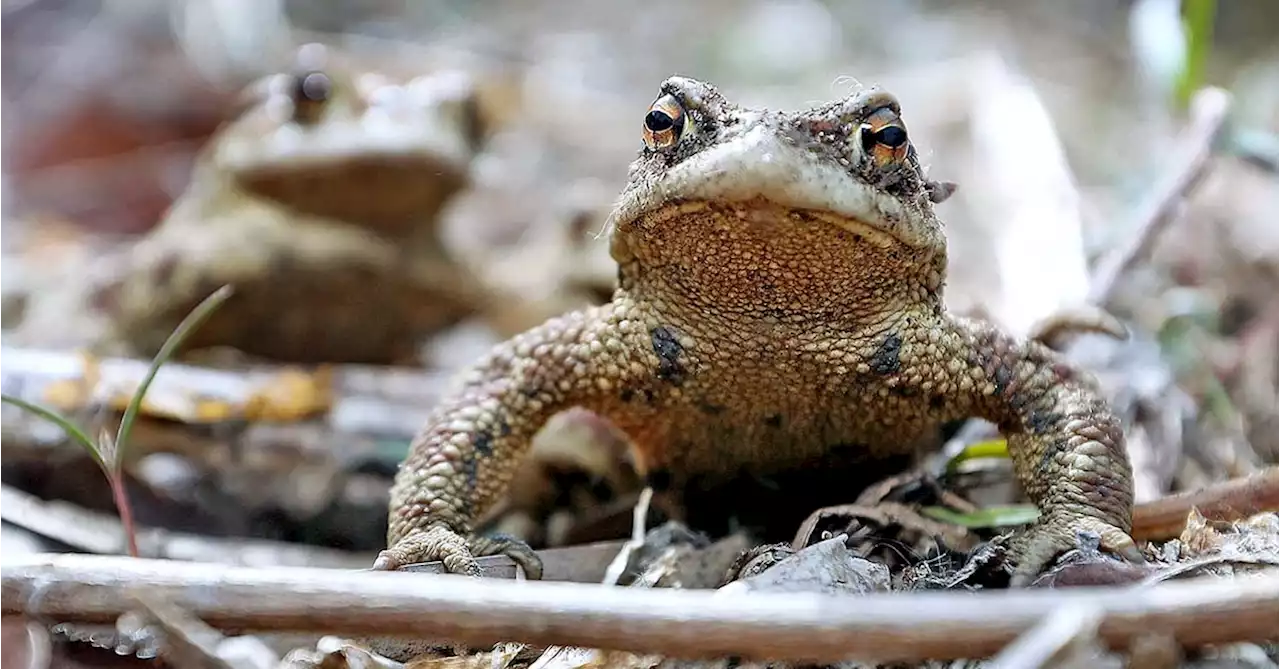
372;524;543;581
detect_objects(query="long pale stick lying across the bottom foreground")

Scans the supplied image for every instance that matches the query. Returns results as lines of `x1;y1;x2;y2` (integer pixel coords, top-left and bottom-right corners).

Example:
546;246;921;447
0;555;1280;663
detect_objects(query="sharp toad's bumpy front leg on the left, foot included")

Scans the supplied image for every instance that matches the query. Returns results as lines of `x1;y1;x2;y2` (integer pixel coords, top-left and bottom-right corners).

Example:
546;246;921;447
374;303;643;578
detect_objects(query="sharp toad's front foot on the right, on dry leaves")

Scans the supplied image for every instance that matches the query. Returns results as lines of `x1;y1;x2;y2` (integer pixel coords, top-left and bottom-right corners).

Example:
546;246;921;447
1009;512;1146;587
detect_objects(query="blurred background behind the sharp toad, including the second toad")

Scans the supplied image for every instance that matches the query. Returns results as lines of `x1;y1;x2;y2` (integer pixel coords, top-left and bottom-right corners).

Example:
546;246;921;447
0;0;1280;585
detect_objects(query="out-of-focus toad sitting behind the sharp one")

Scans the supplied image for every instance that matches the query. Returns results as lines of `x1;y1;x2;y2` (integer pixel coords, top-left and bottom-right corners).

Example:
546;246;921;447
23;45;499;363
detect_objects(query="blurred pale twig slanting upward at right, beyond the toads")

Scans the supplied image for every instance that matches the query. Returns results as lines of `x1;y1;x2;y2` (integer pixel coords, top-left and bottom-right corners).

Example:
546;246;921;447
1089;88;1231;307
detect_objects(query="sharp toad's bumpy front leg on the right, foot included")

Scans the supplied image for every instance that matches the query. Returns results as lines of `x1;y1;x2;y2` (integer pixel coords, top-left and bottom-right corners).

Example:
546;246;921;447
947;319;1143;586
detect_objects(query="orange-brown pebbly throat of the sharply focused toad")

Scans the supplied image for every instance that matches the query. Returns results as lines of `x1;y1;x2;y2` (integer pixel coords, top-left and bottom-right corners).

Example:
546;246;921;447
614;198;933;322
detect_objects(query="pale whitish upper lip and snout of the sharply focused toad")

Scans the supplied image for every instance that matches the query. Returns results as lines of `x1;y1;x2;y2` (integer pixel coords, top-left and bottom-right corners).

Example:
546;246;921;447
609;124;941;248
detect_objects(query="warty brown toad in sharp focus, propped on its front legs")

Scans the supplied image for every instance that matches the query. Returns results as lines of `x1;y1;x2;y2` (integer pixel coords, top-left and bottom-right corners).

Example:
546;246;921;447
375;77;1140;585
